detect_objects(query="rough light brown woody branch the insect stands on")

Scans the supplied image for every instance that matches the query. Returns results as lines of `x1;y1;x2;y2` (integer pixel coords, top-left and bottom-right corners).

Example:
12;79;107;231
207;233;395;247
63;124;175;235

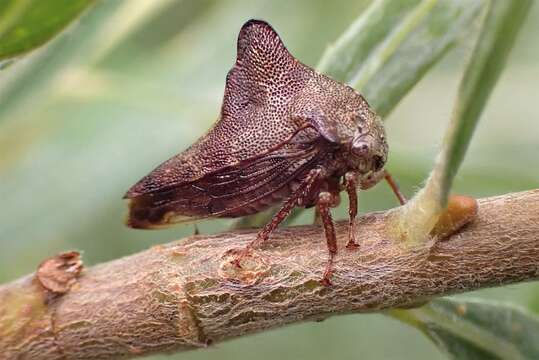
0;190;539;359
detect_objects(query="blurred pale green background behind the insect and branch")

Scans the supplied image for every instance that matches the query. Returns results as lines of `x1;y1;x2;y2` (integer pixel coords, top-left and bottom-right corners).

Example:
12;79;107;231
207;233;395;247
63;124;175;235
0;0;539;360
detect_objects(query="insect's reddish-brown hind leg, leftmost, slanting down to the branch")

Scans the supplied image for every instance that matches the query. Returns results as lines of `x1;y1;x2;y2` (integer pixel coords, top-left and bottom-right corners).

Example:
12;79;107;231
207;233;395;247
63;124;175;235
233;168;324;267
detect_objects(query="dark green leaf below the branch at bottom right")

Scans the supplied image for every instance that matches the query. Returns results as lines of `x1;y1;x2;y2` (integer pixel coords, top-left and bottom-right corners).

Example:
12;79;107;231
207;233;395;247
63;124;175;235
389;298;539;360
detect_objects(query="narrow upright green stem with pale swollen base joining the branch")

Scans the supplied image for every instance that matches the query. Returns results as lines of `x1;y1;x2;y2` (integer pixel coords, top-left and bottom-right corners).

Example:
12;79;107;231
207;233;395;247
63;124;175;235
394;0;532;245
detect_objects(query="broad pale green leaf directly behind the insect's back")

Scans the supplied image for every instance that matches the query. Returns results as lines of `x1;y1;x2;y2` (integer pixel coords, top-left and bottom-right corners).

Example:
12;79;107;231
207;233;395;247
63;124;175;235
318;0;484;116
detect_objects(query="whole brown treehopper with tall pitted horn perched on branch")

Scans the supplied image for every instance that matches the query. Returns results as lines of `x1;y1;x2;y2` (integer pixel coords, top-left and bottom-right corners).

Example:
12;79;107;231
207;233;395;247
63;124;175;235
125;20;404;284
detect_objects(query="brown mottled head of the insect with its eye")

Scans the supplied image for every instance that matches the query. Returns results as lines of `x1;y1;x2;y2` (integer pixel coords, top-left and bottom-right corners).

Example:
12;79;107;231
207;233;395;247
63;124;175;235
349;116;388;173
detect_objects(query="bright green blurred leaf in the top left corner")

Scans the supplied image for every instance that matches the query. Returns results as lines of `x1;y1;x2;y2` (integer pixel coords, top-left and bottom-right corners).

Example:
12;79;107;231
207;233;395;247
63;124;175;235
0;0;94;60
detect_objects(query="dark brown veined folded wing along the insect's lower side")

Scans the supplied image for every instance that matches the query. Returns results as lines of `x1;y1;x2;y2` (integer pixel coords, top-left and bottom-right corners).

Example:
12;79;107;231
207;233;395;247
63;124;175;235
128;141;321;228
